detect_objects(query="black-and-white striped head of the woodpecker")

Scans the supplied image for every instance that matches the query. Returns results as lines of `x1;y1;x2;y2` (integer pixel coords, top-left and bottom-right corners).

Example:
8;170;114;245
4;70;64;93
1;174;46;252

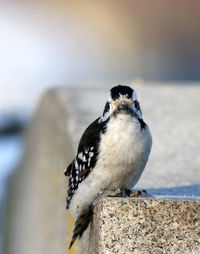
101;85;142;121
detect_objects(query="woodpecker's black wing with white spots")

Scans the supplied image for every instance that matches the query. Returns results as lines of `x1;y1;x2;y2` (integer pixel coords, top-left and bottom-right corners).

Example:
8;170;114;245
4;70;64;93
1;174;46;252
65;118;107;209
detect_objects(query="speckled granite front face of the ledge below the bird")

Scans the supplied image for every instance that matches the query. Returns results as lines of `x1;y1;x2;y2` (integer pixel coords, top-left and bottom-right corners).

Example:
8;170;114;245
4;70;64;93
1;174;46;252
90;198;200;254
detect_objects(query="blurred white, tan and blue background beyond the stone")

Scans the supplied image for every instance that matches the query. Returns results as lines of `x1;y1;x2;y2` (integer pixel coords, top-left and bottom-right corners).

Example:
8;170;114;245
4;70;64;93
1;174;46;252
0;0;200;252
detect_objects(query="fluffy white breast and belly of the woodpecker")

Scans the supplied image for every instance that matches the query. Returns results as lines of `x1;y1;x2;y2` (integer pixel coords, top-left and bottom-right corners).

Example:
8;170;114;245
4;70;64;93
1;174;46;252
96;114;152;189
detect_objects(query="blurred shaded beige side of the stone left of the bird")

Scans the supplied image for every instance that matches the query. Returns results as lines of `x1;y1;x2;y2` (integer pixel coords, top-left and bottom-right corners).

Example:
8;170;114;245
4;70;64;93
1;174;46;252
4;89;78;254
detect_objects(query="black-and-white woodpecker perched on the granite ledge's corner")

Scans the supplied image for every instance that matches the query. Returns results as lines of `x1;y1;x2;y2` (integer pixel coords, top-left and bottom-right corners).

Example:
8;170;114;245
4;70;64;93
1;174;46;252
64;85;152;249
